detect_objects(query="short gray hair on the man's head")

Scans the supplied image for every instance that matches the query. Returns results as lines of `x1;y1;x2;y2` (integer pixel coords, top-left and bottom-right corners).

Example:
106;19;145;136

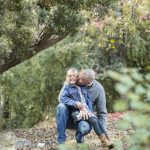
81;68;95;81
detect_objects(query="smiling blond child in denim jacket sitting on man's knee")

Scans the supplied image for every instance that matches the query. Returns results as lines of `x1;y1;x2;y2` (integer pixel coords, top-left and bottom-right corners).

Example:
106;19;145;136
60;68;113;149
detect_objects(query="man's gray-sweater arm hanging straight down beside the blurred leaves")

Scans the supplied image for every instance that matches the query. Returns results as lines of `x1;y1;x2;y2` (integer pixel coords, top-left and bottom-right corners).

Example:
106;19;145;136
95;86;107;129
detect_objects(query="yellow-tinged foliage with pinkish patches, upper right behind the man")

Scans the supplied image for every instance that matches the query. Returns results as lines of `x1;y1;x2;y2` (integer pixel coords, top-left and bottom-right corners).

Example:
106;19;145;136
68;0;150;111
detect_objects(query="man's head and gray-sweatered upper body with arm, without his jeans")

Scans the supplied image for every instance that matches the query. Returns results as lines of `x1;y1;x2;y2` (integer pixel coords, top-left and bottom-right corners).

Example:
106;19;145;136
78;69;107;130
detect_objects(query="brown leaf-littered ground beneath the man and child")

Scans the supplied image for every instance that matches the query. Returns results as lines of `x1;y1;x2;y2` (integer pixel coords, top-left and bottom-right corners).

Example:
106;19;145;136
0;113;133;150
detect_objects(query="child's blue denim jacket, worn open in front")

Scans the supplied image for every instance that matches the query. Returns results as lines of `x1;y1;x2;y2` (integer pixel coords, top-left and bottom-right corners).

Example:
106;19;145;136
60;84;93;111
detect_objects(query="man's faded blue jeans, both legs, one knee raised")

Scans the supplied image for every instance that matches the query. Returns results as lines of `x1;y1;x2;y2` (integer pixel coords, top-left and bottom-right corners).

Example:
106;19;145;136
56;103;92;144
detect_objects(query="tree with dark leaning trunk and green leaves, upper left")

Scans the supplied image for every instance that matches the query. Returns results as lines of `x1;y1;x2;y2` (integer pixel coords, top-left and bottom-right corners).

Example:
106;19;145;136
0;0;115;74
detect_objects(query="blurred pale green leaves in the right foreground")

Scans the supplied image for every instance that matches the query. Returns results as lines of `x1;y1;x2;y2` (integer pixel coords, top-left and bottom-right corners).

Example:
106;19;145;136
109;69;150;150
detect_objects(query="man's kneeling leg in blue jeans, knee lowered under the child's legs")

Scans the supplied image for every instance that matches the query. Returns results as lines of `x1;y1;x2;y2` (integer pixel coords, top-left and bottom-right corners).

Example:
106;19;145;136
76;120;92;143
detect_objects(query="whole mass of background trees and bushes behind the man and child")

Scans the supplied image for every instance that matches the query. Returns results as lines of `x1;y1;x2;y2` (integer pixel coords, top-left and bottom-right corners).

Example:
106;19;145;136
0;0;150;128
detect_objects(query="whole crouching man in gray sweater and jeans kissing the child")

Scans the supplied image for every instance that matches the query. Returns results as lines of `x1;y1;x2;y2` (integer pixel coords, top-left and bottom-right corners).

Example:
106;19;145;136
56;69;107;144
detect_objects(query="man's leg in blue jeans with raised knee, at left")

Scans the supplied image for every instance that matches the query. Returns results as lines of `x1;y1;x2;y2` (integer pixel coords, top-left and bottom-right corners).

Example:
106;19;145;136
56;103;70;144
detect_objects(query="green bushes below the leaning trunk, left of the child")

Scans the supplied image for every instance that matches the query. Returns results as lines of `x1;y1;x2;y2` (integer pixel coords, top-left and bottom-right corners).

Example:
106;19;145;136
0;39;85;128
